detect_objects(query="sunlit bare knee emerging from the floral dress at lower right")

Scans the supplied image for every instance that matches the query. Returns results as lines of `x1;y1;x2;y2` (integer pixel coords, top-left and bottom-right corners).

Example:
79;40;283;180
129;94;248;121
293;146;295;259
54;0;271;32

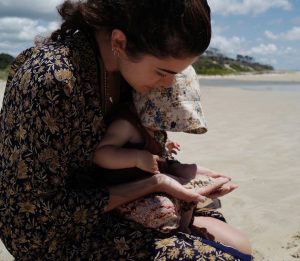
192;217;251;255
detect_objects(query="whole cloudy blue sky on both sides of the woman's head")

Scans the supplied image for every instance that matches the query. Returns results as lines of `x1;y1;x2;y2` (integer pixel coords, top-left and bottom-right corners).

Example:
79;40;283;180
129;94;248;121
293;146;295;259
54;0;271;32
0;0;300;71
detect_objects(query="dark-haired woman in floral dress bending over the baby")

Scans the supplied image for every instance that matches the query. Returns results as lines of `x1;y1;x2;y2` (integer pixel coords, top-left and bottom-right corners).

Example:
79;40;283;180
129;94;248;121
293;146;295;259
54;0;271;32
0;0;250;260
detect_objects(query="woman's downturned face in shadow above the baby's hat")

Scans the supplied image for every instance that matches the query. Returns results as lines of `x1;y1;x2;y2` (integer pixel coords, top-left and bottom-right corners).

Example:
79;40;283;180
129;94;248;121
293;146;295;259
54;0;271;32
118;55;197;93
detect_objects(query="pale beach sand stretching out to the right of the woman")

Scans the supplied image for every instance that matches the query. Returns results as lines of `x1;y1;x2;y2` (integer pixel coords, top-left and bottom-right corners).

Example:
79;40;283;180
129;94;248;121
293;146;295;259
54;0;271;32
0;74;300;261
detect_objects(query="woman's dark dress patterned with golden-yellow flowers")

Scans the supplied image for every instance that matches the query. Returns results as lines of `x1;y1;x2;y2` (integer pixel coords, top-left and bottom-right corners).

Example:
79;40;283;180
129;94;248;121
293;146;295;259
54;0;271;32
0;32;250;261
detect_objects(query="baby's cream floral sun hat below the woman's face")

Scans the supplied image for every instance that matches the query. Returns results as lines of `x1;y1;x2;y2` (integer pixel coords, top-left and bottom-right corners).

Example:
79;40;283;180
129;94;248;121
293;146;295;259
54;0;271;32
133;66;207;134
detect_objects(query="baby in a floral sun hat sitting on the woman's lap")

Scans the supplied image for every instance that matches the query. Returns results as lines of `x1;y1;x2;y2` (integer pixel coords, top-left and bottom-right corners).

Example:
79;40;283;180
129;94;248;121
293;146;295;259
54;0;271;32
94;67;234;233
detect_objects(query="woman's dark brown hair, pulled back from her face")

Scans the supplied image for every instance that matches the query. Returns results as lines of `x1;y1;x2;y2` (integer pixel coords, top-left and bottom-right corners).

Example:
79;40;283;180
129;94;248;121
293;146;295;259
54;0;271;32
51;0;211;58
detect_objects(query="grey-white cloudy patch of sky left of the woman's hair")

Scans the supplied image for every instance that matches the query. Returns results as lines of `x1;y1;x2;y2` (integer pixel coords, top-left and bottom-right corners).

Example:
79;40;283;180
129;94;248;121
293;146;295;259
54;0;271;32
0;0;63;55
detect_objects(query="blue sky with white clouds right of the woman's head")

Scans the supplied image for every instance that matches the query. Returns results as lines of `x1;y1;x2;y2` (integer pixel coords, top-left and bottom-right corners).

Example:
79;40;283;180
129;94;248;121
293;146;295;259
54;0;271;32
209;0;300;70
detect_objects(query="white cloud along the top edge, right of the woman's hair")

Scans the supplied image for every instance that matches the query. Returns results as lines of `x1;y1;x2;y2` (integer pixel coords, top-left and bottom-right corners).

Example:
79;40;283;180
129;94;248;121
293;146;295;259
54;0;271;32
209;0;292;15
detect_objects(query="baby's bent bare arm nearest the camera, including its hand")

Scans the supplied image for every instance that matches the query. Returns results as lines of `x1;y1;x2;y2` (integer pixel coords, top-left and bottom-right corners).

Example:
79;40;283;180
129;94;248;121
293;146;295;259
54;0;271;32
94;120;159;174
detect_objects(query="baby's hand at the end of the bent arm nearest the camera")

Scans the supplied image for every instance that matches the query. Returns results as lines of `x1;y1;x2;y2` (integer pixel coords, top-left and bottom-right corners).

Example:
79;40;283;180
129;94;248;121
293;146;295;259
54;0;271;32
136;150;160;174
